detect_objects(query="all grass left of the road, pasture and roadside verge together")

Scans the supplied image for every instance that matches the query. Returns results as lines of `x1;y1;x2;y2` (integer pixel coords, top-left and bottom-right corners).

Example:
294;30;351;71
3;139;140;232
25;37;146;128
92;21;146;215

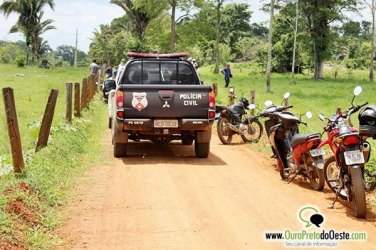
0;65;107;249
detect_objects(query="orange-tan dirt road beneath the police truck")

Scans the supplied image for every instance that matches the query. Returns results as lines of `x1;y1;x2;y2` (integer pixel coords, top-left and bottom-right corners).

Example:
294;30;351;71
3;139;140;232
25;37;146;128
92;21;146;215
62;130;376;249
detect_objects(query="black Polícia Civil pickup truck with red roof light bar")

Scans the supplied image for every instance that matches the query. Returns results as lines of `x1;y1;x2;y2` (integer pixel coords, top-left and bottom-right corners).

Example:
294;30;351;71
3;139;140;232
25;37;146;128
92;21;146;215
110;52;215;158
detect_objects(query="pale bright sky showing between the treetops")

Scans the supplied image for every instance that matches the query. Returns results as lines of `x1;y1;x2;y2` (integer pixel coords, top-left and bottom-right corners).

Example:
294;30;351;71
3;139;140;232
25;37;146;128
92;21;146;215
0;0;370;53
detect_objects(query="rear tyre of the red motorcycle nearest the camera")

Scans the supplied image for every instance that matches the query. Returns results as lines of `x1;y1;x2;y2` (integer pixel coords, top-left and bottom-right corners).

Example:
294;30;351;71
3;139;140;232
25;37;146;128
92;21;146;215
349;166;367;218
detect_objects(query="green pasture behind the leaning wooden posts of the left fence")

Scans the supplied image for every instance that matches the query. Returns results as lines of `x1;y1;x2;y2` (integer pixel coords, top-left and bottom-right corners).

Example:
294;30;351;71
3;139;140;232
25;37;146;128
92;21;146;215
0;64;88;159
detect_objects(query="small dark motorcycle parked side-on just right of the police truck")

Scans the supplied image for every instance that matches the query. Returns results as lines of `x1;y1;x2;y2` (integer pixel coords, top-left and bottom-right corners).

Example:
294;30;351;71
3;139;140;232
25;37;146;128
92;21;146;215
216;97;263;144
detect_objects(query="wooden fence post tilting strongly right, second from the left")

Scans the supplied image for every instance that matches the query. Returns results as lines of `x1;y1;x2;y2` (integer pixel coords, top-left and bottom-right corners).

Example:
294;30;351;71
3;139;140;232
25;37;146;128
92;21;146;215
35;89;59;152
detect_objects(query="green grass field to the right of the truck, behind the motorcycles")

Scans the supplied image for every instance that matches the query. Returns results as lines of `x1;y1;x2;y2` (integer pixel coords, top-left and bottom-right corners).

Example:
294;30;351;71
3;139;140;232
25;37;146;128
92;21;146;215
200;63;376;167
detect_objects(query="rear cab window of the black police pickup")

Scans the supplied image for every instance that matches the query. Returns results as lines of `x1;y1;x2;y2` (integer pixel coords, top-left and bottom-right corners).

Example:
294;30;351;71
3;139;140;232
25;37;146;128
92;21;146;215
121;60;200;85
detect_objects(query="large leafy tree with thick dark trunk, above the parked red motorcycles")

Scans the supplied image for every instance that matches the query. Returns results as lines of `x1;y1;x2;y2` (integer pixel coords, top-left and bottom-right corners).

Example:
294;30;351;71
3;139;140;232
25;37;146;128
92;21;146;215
301;0;357;80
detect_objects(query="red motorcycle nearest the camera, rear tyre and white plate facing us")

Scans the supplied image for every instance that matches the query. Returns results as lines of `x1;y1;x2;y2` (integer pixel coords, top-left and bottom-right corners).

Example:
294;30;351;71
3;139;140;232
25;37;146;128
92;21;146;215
319;86;368;218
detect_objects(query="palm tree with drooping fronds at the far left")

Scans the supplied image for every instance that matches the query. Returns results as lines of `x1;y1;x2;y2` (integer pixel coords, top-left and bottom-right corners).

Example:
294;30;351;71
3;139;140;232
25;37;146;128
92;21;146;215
0;0;55;63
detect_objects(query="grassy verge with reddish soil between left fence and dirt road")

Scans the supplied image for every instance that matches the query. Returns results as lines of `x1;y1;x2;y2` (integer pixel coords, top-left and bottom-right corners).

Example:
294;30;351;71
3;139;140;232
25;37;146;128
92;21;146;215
0;100;107;249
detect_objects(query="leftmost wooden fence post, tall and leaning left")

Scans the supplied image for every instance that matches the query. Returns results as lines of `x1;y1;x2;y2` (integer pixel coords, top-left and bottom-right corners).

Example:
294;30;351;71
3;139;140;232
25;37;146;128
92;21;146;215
3;88;25;173
